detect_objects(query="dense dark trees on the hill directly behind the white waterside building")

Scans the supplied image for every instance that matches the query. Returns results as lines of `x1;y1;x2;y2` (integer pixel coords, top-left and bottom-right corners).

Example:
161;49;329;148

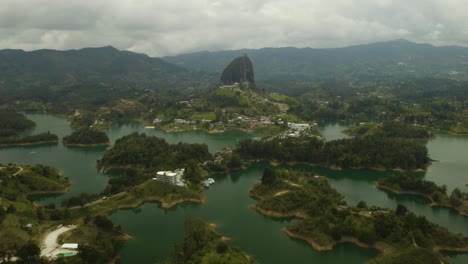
98;133;211;170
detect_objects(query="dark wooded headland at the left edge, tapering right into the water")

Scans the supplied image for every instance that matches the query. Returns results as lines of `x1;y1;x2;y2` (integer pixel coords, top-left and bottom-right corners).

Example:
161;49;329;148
0;109;36;138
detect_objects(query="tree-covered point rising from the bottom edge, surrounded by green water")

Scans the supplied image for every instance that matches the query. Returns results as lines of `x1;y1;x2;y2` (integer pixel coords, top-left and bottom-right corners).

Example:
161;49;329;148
162;217;253;264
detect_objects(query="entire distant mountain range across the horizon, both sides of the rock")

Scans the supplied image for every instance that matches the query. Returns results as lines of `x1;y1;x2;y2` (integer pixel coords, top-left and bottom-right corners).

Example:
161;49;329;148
0;40;468;93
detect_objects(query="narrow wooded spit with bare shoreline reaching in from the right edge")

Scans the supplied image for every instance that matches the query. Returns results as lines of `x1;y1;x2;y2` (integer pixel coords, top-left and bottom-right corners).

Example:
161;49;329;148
377;174;468;216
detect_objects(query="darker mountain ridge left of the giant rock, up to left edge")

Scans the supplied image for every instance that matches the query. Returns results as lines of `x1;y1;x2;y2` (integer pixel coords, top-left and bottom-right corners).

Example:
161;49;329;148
0;46;215;89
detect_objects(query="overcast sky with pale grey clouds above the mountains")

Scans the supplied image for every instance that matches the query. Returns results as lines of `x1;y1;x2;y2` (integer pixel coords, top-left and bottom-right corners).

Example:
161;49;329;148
0;0;468;56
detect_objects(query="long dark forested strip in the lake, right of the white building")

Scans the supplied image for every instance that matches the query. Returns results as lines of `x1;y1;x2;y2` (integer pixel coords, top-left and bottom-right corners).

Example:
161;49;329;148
236;136;430;169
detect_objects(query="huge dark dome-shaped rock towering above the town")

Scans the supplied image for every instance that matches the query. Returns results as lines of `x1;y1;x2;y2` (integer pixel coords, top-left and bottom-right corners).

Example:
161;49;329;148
220;55;255;88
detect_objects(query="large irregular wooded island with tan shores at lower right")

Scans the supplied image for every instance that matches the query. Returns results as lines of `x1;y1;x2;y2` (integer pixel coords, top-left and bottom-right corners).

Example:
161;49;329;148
250;168;468;263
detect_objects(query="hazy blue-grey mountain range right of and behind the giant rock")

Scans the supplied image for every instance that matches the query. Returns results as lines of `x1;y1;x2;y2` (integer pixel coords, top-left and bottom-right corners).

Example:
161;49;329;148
163;40;468;81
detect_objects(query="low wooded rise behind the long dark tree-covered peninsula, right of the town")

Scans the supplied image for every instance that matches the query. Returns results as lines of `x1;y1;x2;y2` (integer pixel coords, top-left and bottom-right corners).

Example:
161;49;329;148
345;121;434;140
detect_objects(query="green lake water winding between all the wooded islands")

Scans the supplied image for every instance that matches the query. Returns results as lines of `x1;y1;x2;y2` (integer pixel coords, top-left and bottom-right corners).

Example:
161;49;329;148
0;114;468;264
